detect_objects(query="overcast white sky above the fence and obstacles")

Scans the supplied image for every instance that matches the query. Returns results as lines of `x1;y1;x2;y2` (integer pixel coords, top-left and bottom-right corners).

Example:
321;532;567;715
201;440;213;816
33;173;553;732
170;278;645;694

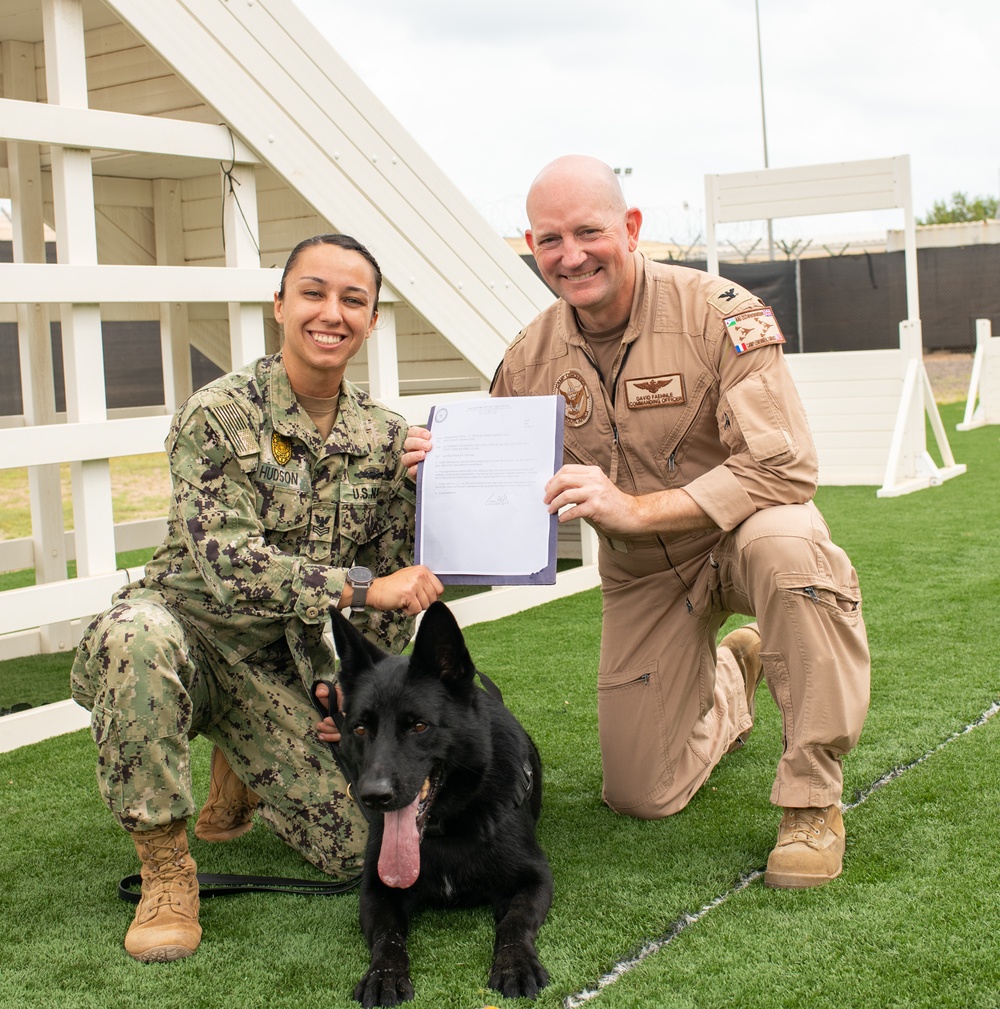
297;0;1000;241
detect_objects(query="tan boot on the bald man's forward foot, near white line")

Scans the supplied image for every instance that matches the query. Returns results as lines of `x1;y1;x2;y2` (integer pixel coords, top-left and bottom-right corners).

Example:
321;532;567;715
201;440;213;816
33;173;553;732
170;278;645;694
764;802;845;890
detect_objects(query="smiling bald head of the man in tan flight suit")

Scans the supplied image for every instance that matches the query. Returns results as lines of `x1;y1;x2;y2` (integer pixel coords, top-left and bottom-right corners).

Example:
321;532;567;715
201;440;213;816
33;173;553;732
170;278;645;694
525;155;642;332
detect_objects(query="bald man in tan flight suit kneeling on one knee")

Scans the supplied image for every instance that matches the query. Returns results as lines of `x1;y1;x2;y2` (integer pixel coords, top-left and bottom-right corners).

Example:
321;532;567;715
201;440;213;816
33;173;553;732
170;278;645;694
404;156;870;887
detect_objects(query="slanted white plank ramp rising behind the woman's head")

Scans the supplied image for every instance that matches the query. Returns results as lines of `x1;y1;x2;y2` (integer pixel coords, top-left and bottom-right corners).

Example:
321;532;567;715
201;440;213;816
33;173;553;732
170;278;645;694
105;0;552;385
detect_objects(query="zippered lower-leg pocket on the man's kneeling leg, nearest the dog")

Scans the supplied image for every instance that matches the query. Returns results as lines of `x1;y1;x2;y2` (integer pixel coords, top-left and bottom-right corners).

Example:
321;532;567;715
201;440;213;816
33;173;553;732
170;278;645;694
597;660;673;811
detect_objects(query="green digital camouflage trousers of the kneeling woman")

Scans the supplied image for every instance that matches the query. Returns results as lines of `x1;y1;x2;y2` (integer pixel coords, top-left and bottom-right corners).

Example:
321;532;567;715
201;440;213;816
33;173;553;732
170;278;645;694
72;596;367;875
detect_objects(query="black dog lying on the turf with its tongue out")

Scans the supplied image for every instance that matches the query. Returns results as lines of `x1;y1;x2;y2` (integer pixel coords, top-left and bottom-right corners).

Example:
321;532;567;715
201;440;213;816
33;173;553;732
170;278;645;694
332;602;552;1006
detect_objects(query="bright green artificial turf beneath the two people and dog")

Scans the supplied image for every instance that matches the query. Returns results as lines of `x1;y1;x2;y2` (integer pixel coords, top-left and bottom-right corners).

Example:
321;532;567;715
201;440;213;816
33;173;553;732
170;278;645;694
0;407;1000;1009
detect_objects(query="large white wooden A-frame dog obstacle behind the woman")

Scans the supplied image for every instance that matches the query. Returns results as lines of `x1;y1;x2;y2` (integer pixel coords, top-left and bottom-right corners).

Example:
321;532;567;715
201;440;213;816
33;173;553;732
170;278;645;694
0;0;597;702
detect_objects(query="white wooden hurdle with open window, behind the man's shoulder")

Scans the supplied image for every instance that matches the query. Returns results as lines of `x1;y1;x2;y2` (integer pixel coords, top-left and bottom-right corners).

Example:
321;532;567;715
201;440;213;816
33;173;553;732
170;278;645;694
705;154;966;497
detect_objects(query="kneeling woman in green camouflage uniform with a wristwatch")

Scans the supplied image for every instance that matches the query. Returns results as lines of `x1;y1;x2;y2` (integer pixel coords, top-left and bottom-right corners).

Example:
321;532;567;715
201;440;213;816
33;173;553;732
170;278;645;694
73;235;443;961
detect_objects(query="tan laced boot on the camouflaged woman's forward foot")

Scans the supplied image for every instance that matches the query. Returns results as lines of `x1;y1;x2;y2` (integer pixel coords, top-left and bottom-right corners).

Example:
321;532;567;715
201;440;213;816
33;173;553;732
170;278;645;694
125;820;202;964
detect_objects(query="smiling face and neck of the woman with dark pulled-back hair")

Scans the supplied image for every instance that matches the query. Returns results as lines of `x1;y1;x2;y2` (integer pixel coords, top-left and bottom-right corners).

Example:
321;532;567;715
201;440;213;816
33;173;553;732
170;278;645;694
274;244;378;399
